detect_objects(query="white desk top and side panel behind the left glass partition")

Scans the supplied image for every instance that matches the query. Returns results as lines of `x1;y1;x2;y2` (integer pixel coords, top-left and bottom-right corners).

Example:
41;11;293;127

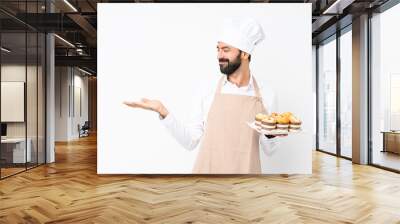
1;138;32;163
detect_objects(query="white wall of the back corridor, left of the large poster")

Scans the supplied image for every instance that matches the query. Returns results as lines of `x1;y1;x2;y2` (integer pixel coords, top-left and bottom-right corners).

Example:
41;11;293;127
55;67;88;141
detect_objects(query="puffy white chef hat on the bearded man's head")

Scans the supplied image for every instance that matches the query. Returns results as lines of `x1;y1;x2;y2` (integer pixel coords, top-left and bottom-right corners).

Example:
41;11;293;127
217;18;265;54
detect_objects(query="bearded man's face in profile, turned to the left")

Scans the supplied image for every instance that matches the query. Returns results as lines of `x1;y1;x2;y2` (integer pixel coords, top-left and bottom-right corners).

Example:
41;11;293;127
217;42;242;76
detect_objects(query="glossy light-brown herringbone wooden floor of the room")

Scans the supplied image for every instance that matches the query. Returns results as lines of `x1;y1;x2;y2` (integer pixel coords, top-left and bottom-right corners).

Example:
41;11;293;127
0;134;400;224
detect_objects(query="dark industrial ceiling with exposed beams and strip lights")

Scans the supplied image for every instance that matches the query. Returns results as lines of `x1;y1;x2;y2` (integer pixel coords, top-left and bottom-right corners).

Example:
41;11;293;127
0;0;394;73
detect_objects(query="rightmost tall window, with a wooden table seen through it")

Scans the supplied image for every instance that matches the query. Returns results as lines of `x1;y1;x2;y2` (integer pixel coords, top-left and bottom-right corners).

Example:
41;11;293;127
370;4;400;170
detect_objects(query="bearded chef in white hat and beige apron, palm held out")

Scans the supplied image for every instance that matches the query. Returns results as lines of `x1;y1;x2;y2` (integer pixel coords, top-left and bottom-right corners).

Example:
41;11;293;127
125;19;282;174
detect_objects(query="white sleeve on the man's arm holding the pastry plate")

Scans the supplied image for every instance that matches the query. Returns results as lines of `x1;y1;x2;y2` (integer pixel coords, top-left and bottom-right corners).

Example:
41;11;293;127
260;86;280;155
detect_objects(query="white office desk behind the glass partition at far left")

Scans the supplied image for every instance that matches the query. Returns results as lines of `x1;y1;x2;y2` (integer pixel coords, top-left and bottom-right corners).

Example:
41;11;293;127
1;138;32;163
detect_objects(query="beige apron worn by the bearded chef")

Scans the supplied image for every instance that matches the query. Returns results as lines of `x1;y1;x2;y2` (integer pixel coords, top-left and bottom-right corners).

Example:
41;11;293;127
193;77;266;174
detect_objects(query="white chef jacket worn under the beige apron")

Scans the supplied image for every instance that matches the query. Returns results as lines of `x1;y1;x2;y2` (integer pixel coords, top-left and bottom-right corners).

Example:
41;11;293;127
161;75;278;154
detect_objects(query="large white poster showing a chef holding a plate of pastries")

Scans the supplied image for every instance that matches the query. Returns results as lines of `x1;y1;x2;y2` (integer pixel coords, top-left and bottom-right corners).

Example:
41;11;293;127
97;3;314;174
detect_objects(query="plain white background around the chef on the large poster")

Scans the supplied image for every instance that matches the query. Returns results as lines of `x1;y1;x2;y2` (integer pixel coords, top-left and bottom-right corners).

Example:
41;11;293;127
97;3;314;174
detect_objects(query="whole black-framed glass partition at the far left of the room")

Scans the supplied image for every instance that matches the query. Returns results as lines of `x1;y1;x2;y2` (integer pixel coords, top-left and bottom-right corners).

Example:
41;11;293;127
0;1;46;179
